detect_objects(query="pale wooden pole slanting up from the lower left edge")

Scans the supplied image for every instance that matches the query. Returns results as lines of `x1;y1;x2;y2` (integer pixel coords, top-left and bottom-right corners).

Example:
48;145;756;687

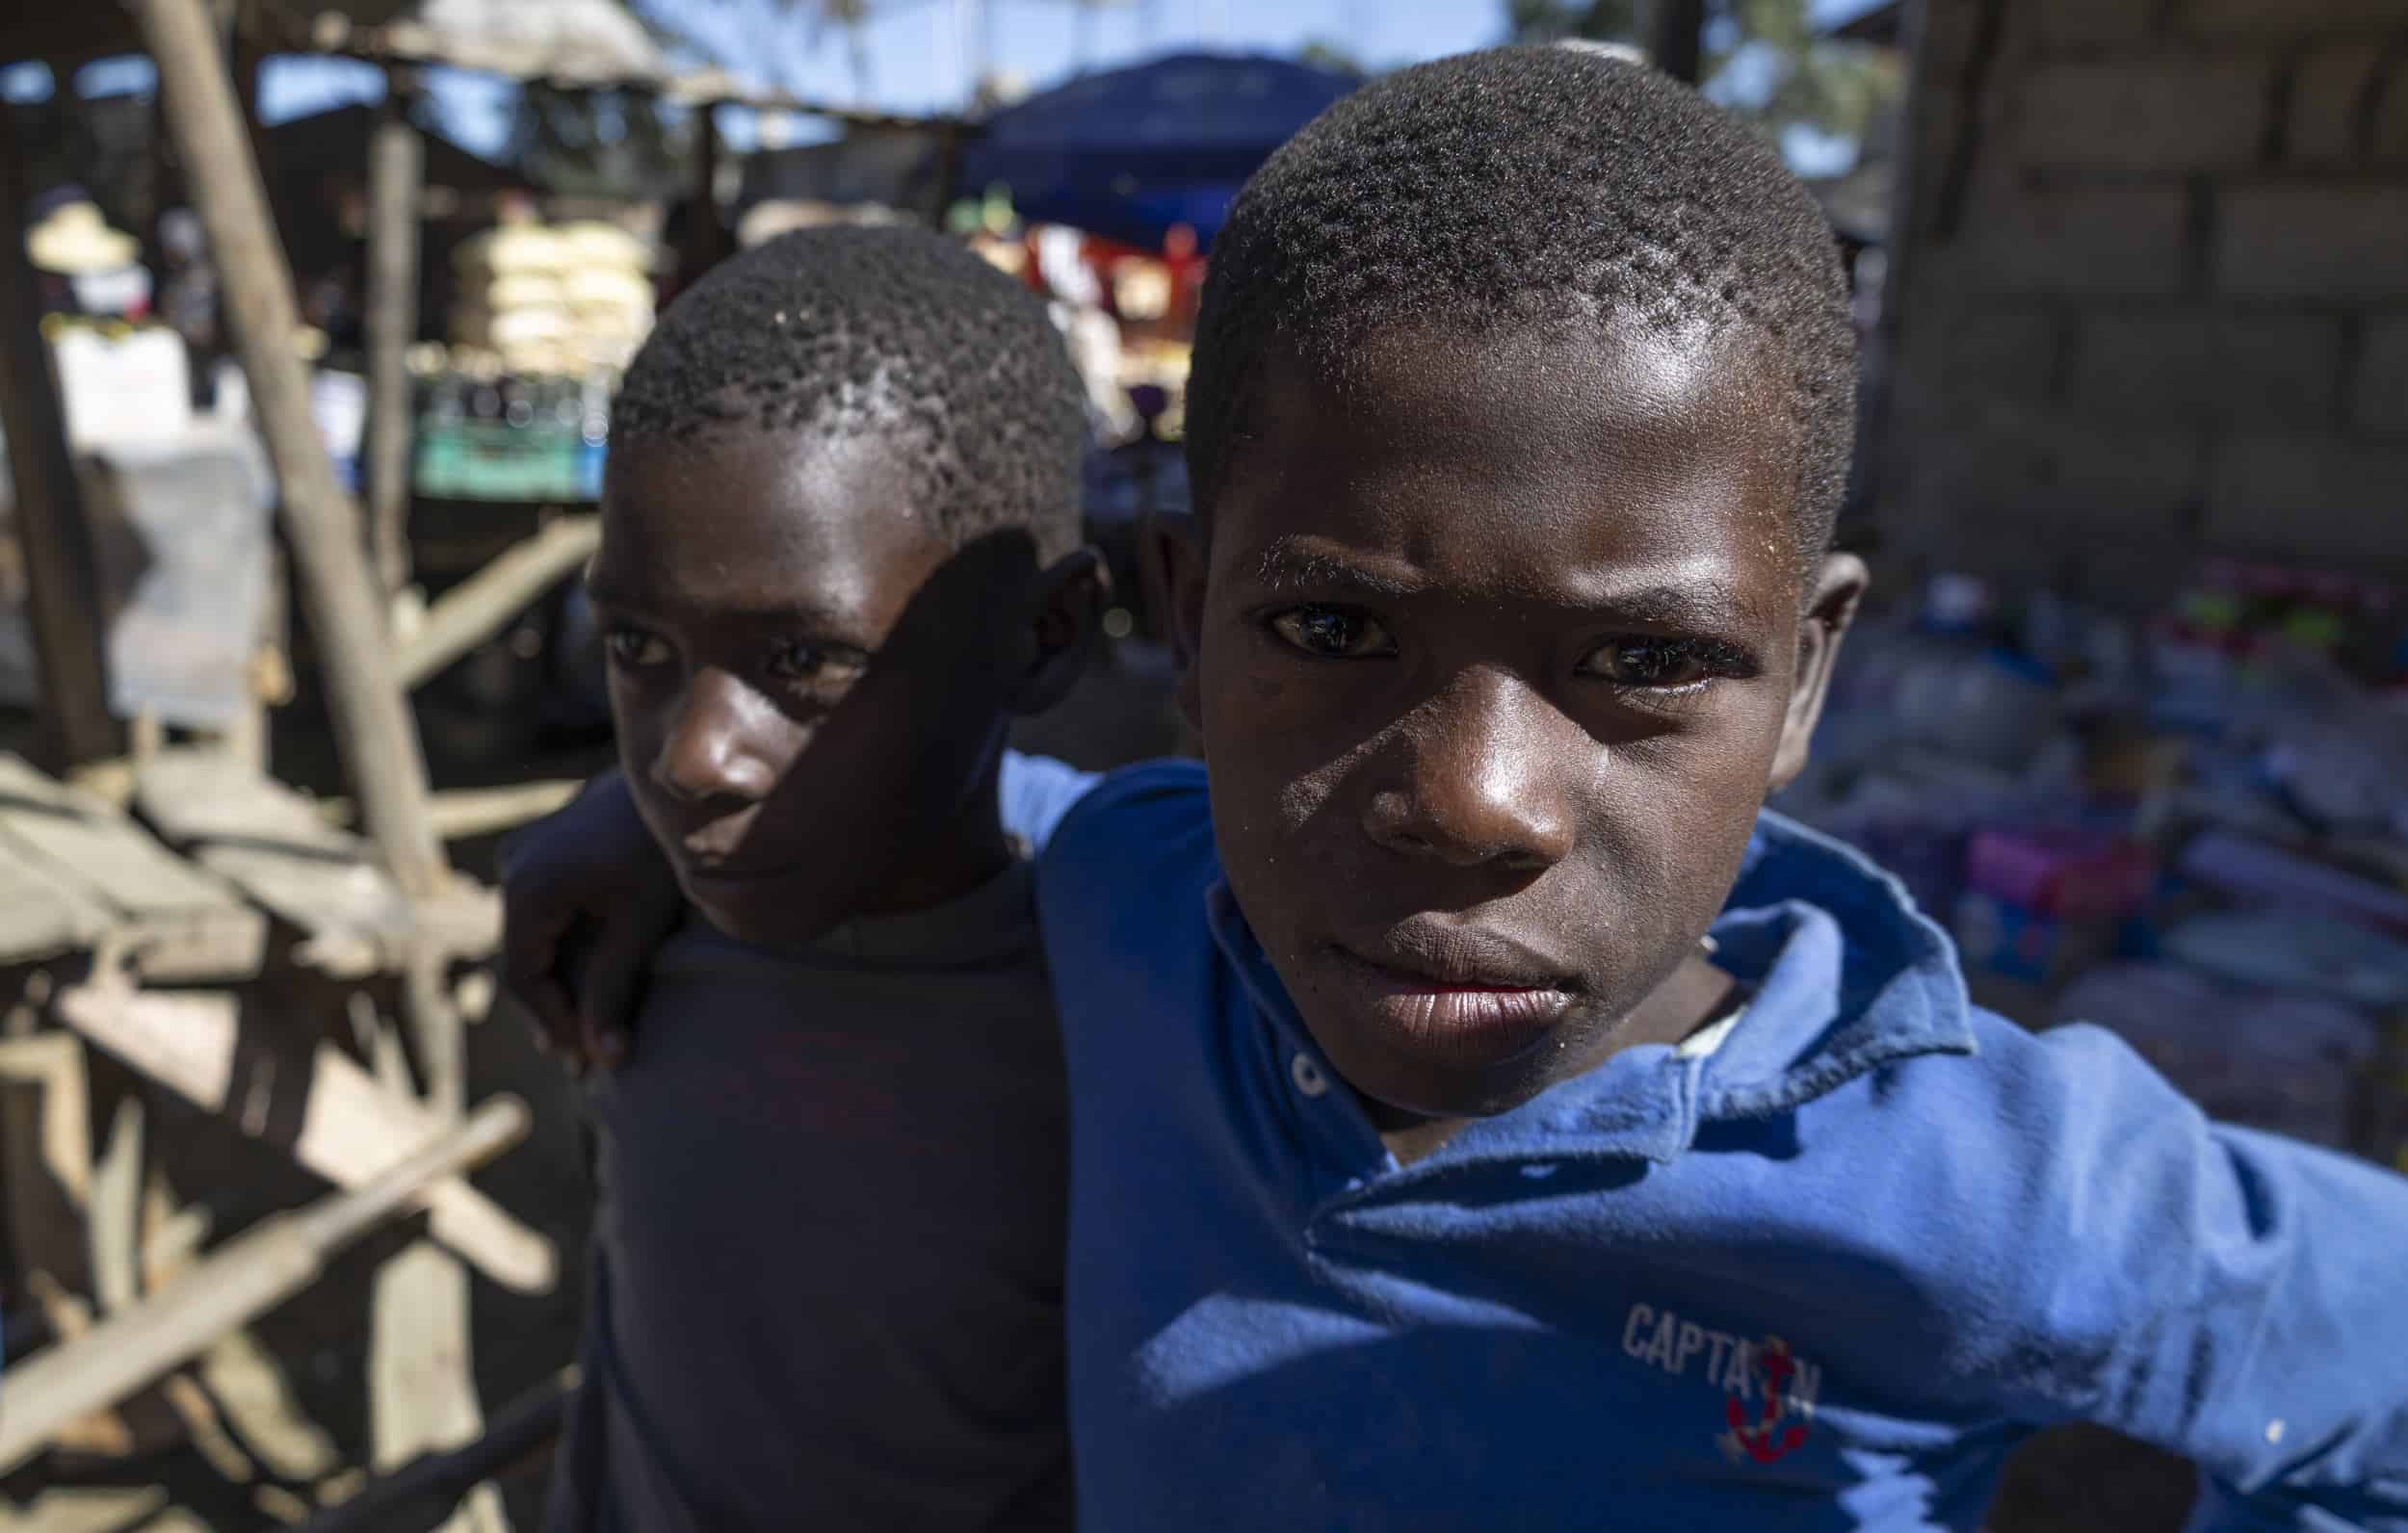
0;1098;530;1475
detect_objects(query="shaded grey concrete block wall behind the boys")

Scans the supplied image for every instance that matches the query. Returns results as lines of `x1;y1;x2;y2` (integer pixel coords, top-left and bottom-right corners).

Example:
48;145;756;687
1871;0;2408;604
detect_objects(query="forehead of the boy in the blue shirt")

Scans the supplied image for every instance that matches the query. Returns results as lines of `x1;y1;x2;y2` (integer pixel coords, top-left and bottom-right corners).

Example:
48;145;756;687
1212;323;1796;601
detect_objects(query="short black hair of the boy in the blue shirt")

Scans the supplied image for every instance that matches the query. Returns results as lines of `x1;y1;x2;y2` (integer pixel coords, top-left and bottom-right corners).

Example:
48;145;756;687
1188;48;1857;560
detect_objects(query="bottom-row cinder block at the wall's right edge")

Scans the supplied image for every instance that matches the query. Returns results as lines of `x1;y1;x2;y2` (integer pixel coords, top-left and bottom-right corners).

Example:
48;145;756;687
2206;430;2408;568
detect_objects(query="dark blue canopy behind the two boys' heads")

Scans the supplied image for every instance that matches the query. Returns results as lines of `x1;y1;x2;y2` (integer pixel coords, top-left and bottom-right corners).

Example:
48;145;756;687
961;53;1358;247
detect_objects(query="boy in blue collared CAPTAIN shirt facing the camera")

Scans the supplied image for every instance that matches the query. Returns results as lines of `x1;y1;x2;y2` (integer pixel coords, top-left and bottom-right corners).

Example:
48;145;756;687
513;50;2408;1531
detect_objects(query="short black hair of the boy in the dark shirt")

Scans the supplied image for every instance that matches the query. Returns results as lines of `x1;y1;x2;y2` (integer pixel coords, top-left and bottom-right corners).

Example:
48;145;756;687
612;223;1086;559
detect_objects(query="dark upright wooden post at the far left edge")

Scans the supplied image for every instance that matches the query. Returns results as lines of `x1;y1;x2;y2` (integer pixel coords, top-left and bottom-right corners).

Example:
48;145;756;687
0;103;118;772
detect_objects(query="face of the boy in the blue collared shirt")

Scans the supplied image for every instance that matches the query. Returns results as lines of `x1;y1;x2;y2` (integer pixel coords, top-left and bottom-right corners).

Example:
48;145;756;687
1178;323;1862;1117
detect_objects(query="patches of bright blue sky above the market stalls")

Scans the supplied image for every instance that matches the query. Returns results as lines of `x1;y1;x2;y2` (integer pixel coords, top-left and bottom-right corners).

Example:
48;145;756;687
0;0;1873;173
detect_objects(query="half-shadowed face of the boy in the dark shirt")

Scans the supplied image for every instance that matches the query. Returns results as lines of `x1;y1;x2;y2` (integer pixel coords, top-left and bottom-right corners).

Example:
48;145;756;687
588;418;1084;946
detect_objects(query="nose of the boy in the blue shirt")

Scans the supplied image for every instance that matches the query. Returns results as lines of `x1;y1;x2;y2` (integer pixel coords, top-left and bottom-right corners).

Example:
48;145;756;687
1363;669;1587;871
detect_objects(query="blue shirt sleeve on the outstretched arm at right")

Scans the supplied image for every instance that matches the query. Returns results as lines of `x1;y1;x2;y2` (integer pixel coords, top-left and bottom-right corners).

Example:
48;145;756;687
1994;1027;2408;1533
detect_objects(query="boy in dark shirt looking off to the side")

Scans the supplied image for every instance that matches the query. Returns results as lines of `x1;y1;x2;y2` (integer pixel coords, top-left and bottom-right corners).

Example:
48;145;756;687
520;228;1098;1533
